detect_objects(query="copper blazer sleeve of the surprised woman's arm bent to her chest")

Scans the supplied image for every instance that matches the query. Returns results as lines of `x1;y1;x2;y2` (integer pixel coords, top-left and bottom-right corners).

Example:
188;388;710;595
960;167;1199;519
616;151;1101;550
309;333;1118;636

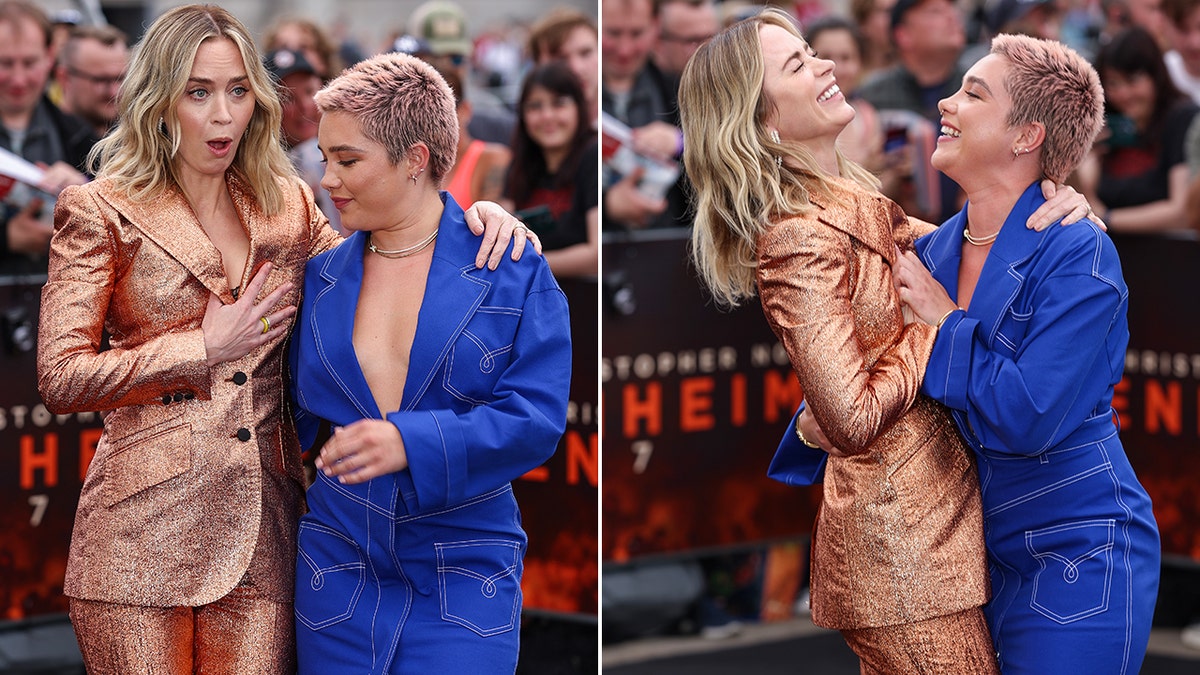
37;187;209;414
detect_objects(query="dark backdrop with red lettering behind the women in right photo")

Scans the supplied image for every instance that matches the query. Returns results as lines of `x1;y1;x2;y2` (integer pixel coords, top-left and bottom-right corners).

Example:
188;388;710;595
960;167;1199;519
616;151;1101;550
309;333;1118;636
601;232;1200;568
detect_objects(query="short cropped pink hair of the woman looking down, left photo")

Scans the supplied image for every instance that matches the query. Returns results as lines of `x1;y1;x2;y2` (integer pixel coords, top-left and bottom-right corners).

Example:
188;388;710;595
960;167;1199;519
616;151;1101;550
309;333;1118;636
314;54;458;187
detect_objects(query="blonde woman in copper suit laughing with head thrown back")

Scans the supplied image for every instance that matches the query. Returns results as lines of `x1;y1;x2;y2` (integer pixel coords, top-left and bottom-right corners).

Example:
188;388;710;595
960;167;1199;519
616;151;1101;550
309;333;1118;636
679;10;1086;675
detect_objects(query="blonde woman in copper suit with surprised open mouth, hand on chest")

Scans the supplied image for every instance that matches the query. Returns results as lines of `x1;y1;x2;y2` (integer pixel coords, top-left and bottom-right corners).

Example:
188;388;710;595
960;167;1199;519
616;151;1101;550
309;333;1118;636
37;5;535;675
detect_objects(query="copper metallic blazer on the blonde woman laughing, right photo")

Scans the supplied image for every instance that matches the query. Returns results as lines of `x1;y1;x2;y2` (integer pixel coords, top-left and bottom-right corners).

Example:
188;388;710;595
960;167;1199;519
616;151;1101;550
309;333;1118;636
757;179;989;628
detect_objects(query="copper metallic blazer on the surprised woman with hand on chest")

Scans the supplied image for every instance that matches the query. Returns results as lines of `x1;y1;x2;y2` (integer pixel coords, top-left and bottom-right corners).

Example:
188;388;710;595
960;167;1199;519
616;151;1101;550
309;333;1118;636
37;174;338;607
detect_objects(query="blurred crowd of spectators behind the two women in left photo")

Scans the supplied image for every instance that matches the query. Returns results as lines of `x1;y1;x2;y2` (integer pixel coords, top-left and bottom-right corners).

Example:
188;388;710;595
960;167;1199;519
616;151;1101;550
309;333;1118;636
0;0;599;276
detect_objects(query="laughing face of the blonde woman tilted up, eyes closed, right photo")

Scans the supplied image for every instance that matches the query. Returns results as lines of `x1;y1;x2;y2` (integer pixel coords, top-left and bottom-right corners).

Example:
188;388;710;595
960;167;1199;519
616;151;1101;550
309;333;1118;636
760;24;854;148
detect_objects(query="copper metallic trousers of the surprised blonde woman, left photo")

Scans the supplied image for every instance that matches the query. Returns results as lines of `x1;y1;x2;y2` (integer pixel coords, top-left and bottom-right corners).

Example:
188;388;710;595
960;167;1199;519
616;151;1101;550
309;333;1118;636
71;585;296;675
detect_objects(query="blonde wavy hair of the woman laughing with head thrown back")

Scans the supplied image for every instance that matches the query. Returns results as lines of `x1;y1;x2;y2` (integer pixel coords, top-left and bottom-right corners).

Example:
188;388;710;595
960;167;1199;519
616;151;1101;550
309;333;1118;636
679;8;880;307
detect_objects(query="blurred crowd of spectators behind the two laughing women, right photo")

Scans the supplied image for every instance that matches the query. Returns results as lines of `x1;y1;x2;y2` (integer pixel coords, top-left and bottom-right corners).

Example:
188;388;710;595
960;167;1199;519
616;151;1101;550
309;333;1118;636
601;0;1200;233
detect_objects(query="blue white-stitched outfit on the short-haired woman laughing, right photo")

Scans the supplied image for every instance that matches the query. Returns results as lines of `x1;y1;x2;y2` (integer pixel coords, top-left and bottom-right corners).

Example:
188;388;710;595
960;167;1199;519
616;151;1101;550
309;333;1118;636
917;184;1160;675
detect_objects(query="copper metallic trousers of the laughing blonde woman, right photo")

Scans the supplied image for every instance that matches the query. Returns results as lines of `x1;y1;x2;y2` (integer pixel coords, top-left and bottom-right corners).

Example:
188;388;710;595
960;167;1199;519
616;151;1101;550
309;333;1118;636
841;608;1000;675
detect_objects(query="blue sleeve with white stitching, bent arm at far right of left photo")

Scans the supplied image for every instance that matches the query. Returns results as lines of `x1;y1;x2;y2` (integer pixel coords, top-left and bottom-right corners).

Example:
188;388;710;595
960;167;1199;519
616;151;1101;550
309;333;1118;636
388;273;571;512
